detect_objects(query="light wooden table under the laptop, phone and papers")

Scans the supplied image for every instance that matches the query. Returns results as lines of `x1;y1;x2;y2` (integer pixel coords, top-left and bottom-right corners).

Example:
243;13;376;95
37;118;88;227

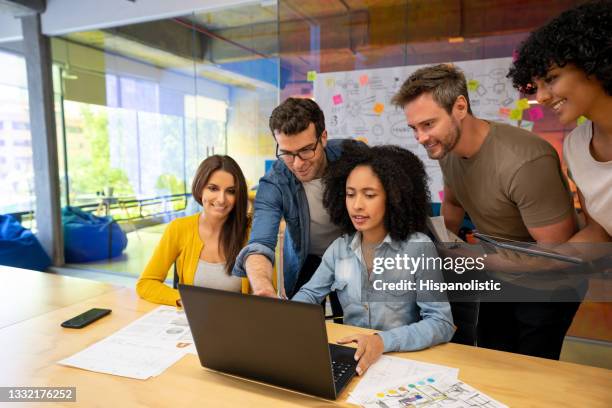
0;270;612;408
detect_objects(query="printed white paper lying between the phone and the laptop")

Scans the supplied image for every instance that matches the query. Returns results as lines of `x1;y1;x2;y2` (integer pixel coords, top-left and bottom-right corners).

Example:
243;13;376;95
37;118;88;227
59;306;196;380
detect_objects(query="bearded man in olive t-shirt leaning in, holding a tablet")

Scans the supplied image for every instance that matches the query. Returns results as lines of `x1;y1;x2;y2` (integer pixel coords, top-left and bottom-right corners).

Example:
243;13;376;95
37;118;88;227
393;64;579;359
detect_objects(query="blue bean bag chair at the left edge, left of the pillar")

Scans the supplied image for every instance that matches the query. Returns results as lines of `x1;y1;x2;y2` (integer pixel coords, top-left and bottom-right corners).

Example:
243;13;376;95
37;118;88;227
0;215;51;271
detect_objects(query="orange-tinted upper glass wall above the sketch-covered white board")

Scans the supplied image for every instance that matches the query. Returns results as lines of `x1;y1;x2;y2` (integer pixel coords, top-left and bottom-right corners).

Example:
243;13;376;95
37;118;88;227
279;0;581;99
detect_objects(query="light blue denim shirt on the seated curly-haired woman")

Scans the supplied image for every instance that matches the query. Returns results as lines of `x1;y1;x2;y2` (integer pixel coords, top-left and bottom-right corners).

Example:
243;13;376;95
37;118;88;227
292;233;455;352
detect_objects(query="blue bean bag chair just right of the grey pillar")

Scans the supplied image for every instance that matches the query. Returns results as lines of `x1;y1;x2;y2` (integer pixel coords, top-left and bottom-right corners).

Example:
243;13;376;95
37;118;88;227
62;207;127;263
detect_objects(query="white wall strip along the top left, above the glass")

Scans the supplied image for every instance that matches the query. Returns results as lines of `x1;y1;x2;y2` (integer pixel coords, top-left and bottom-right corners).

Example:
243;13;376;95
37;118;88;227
0;0;254;42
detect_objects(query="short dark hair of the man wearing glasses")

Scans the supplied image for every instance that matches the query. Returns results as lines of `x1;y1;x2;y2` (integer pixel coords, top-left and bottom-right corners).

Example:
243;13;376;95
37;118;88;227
269;98;325;137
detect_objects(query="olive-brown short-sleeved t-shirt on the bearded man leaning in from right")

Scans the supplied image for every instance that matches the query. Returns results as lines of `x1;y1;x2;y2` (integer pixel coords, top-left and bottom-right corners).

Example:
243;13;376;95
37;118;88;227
440;122;573;241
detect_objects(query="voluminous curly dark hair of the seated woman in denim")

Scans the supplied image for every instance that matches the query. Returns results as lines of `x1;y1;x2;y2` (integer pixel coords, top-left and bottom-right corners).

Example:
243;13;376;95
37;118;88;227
323;140;430;241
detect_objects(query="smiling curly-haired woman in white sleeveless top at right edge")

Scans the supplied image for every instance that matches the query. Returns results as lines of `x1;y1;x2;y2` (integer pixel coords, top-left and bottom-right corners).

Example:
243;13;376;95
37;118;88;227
508;1;612;242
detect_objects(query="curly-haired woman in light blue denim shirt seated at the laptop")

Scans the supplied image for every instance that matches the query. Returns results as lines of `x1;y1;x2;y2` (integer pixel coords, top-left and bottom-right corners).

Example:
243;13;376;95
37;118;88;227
292;141;454;375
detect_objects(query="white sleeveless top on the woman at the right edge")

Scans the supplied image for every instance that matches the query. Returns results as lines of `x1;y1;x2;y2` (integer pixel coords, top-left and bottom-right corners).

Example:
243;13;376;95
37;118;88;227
563;120;612;235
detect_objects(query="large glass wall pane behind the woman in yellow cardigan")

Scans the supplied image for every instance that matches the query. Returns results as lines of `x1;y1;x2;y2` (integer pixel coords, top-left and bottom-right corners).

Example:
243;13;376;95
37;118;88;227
52;3;279;220
